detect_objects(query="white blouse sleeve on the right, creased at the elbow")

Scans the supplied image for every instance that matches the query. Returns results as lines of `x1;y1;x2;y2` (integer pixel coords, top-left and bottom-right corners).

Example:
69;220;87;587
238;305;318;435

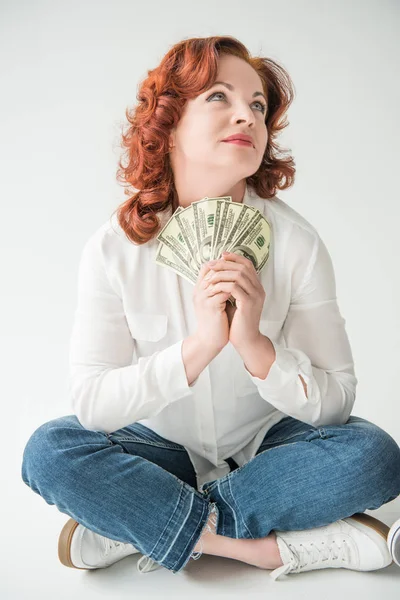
246;235;358;426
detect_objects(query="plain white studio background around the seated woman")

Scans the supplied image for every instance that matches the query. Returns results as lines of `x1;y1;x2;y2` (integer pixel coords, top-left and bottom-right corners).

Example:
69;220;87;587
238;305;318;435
0;0;400;599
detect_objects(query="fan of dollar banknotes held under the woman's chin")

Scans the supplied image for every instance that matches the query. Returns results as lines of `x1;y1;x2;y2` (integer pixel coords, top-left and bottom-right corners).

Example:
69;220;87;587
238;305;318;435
156;196;271;306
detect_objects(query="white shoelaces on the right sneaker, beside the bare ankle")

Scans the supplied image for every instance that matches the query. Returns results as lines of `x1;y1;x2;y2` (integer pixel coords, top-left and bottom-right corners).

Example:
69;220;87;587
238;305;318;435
270;538;351;580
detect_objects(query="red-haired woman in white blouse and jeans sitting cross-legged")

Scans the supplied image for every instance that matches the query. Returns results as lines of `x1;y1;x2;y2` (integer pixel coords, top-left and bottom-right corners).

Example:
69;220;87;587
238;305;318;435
22;37;400;579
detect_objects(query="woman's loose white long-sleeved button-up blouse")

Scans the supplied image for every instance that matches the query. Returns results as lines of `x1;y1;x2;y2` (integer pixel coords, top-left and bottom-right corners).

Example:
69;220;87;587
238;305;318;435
69;186;357;491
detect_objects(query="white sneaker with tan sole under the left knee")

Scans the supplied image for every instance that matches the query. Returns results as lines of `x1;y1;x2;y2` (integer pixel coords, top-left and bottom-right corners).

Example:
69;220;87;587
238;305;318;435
58;519;161;573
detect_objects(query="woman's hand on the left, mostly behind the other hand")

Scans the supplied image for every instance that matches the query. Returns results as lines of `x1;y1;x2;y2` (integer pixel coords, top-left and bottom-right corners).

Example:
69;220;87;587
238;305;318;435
193;263;231;352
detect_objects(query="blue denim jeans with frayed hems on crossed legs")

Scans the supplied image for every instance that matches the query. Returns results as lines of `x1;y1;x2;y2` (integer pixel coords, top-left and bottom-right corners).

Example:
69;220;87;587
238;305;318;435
22;415;400;573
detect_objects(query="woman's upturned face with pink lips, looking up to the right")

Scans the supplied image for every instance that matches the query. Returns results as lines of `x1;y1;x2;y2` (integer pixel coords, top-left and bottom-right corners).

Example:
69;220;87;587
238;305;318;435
170;55;268;183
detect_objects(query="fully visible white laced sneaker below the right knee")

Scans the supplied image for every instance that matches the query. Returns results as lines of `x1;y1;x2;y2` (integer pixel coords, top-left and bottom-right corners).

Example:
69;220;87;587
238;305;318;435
270;513;393;580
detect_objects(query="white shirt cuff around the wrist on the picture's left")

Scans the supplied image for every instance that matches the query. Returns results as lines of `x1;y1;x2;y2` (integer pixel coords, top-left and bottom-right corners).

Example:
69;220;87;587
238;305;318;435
156;339;198;400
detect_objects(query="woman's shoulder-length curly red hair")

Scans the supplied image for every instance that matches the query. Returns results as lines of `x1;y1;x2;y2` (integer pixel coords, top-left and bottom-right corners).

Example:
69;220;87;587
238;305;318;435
113;36;296;244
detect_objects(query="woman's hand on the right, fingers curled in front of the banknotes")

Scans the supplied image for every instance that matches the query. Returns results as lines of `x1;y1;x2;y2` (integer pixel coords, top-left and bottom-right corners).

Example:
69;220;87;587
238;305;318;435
203;252;265;350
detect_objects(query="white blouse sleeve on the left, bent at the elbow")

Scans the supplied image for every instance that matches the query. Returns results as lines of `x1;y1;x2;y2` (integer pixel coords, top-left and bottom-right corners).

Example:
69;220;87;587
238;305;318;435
69;234;196;433
